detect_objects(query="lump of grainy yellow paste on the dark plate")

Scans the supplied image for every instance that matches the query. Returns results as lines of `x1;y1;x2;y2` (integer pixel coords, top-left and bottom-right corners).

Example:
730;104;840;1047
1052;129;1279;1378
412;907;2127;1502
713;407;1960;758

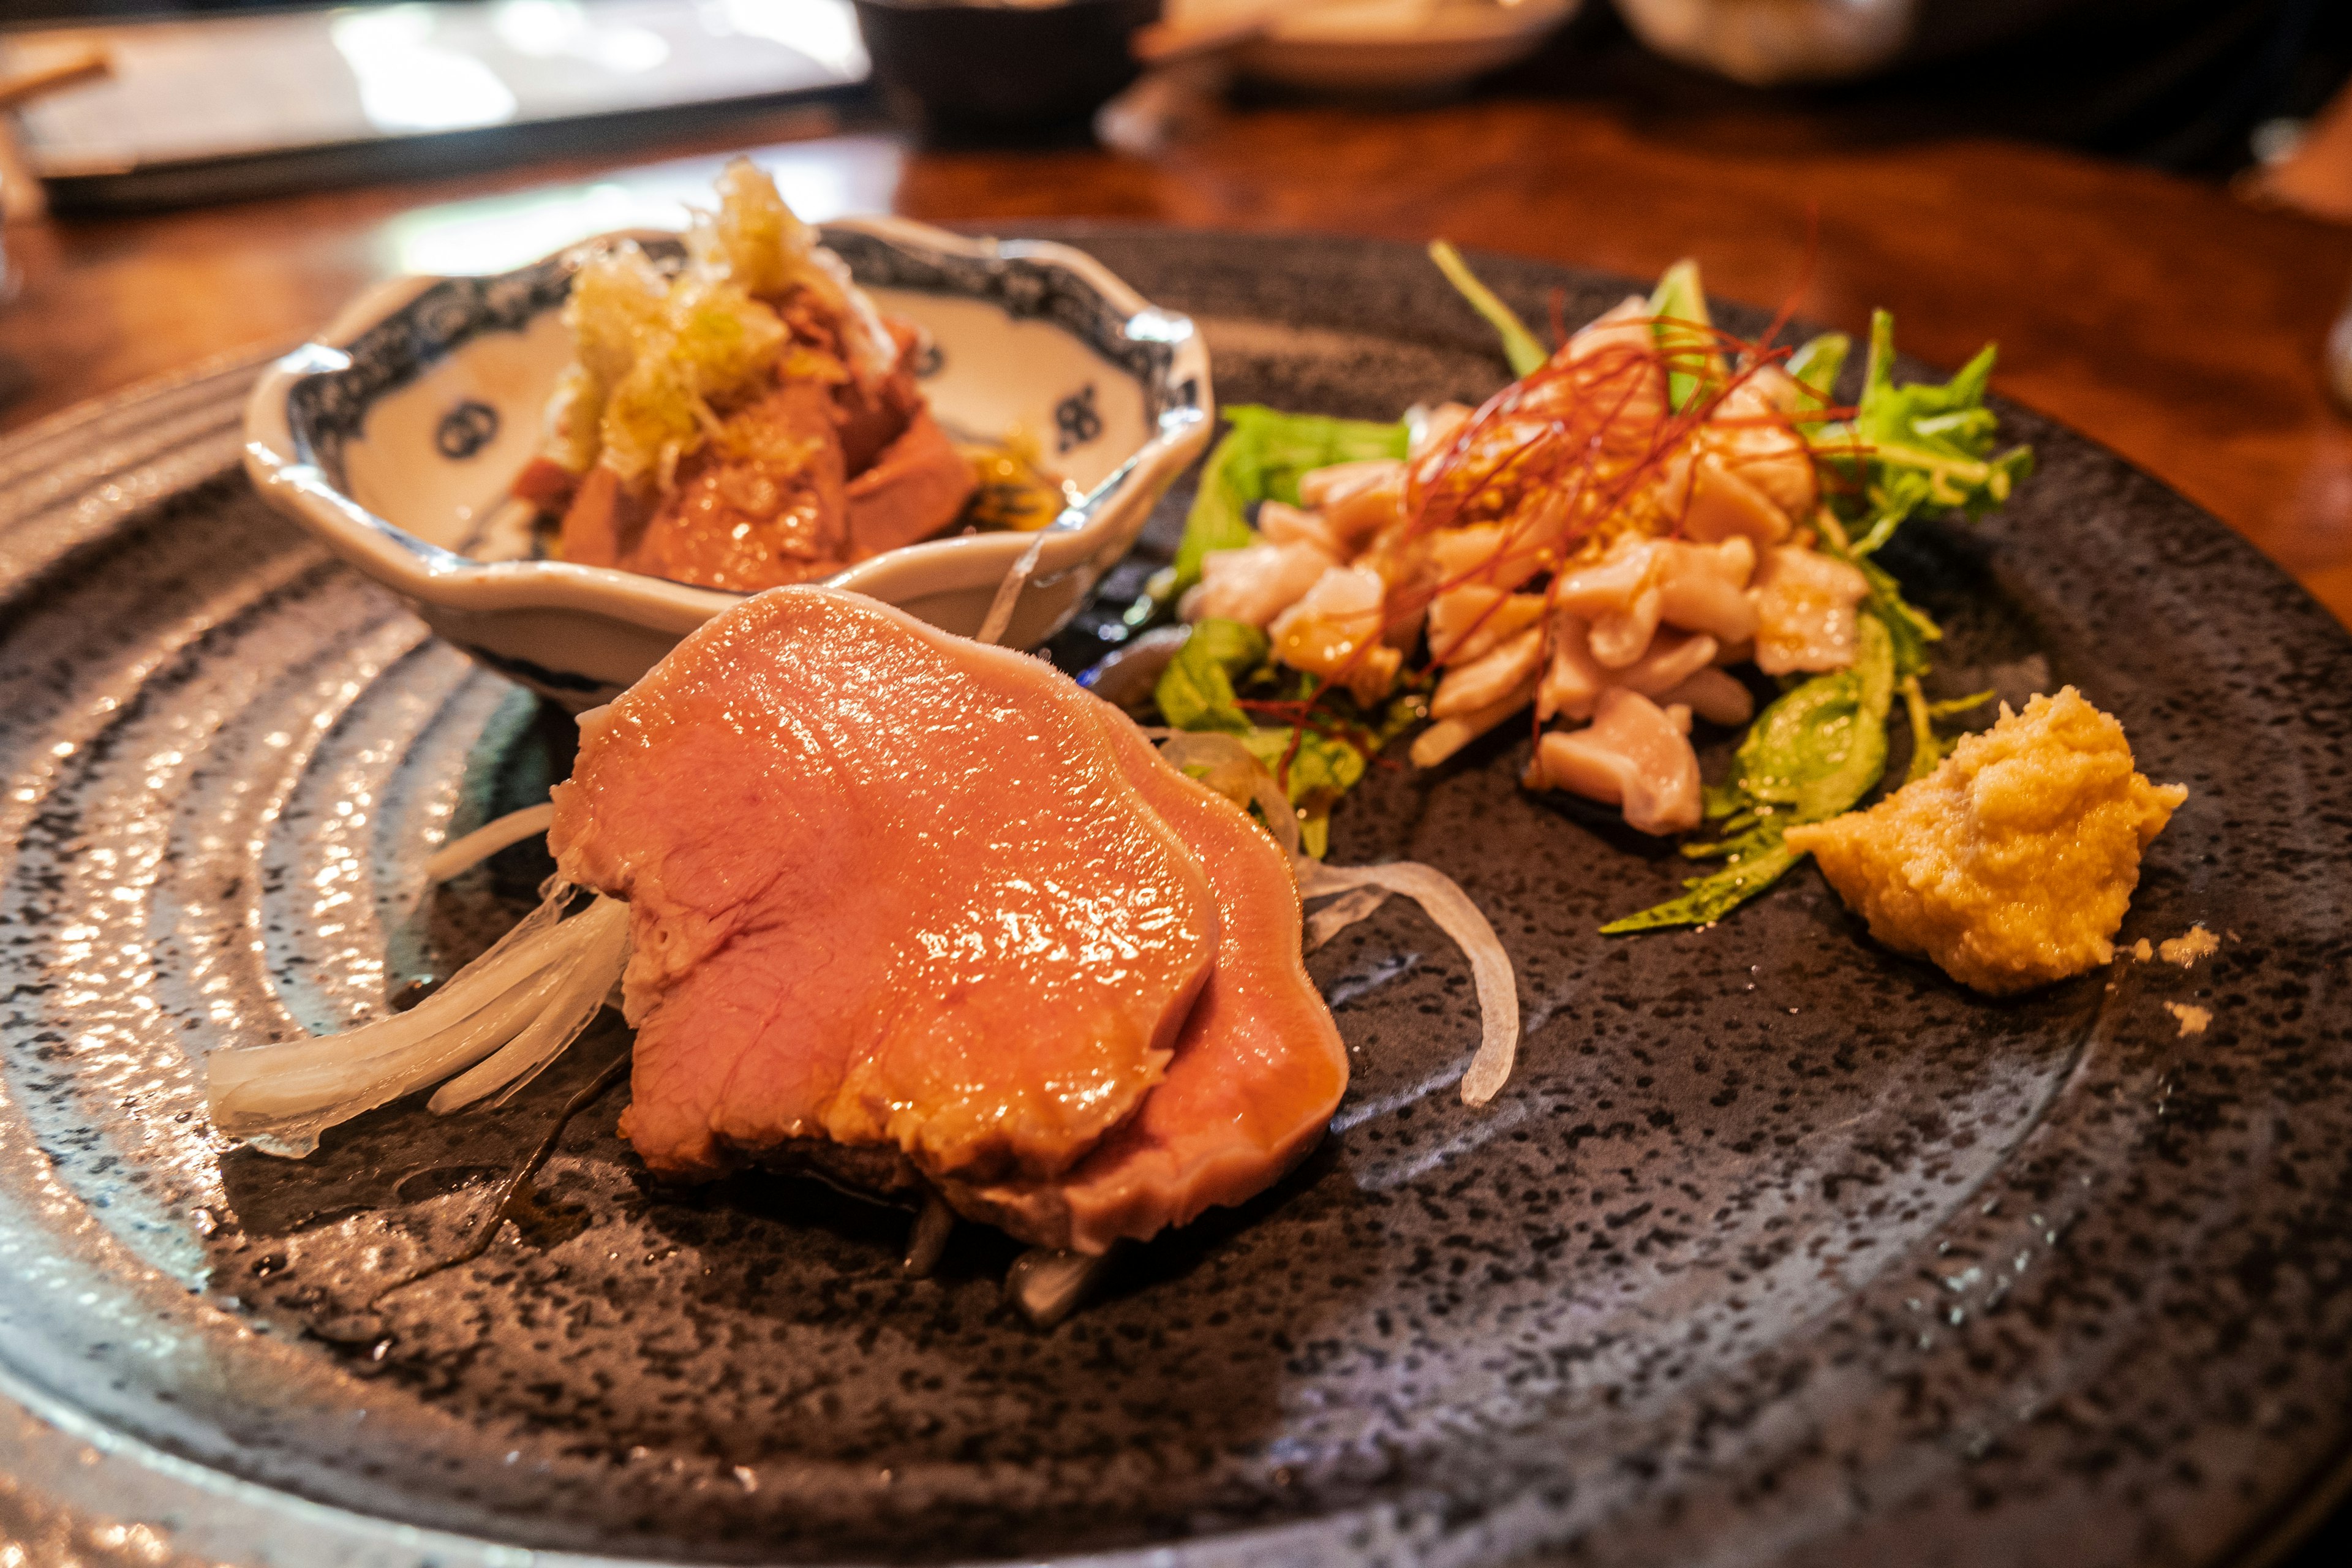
1787;687;2190;995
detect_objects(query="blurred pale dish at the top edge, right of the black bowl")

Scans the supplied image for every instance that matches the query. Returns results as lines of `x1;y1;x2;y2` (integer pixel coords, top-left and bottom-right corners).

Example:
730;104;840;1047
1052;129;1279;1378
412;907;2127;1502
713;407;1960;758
1167;0;1580;94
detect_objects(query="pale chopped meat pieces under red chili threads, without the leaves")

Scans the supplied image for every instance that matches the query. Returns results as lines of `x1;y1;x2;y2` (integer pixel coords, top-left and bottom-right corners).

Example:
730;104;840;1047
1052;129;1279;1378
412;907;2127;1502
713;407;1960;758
1181;298;1870;832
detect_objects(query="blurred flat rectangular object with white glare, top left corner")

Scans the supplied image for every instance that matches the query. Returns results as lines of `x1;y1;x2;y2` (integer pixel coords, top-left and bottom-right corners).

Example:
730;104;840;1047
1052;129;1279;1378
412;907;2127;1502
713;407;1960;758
0;0;865;207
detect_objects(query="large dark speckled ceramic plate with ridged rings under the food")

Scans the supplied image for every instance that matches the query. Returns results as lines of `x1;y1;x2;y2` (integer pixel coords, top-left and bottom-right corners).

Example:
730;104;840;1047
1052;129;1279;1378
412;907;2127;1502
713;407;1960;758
0;233;2352;1568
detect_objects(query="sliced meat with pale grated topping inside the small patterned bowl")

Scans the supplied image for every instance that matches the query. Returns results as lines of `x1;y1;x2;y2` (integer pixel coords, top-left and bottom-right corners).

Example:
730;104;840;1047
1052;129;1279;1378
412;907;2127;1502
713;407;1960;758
515;157;976;590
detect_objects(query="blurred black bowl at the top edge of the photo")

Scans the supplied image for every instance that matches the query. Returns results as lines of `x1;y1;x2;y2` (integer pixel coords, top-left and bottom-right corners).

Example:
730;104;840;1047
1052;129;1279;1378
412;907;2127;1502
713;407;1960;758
856;0;1159;134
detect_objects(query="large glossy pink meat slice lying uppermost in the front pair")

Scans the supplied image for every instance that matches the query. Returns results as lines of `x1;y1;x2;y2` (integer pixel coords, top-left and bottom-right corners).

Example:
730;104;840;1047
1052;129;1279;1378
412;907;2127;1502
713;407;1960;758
551;588;1218;1183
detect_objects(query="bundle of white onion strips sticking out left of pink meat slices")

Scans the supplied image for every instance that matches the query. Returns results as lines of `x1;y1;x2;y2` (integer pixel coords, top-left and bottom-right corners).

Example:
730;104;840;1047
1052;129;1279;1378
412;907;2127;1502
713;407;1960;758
205;881;628;1159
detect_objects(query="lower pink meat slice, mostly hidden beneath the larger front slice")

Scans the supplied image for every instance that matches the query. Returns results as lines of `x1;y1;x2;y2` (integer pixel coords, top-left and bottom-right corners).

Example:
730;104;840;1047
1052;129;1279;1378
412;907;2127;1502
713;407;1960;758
943;696;1348;1253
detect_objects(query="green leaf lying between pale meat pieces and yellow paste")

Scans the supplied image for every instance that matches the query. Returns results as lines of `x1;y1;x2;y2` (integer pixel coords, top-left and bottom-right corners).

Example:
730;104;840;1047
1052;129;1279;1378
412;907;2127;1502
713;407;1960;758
1602;614;1896;936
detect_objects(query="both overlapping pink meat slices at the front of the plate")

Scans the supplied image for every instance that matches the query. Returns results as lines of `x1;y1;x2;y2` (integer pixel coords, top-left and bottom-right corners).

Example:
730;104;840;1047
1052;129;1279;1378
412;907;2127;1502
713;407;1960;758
548;588;1348;1253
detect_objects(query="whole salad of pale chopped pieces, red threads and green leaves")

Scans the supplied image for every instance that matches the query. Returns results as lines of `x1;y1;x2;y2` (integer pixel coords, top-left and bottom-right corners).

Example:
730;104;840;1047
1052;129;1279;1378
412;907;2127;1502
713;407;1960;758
1153;244;2030;931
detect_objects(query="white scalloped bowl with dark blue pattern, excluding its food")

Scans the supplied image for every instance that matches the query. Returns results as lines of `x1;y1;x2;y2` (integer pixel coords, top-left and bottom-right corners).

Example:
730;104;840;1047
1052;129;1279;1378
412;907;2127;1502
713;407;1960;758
244;219;1212;710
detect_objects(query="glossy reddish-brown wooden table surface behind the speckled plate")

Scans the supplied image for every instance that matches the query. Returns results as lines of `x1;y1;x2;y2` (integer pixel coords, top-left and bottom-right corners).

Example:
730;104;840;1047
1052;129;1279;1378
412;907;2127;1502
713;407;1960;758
0;99;2352;620
